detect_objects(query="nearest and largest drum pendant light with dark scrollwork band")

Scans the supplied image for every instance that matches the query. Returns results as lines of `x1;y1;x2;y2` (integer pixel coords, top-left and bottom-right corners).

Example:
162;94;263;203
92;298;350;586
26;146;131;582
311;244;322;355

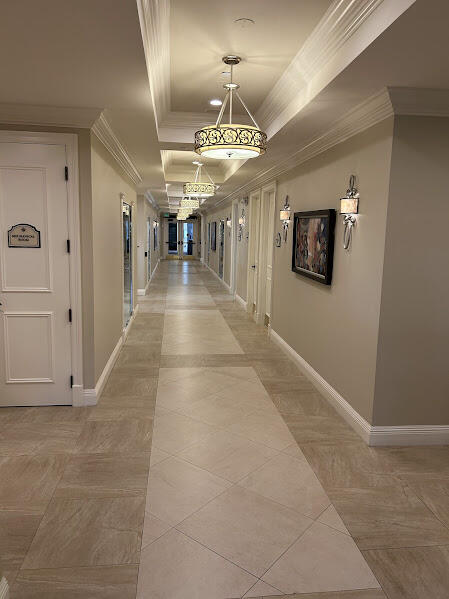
195;55;267;160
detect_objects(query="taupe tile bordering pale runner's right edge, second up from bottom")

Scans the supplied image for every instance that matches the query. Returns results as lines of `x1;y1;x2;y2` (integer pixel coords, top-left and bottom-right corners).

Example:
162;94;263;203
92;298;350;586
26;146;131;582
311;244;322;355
328;486;449;549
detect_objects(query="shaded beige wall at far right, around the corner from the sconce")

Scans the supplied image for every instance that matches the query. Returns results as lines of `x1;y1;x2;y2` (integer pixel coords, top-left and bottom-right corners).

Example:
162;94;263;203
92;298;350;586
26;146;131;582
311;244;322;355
374;117;449;425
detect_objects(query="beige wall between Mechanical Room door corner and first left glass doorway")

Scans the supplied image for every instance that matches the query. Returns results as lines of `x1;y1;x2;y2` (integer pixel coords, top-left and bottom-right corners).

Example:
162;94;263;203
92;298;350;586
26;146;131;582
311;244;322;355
91;135;137;382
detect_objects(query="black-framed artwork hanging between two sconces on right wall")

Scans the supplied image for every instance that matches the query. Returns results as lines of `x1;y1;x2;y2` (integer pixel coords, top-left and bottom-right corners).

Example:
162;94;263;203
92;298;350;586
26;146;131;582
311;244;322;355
292;209;335;285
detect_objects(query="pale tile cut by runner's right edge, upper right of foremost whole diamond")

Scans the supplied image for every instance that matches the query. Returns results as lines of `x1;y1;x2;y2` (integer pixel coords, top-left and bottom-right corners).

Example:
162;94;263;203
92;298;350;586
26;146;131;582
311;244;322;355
239;454;330;519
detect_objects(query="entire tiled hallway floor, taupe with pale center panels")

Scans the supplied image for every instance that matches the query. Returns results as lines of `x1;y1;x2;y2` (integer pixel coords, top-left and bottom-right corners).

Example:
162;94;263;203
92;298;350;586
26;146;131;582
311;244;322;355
0;262;449;599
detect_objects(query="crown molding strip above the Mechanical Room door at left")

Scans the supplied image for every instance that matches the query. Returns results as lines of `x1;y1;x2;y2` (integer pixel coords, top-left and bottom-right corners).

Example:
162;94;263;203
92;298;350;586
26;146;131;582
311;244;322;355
0;104;101;129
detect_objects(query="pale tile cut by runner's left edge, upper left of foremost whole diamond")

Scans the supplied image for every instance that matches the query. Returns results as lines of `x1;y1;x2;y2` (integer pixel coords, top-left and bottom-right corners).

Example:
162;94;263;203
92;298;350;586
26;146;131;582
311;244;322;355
146;458;230;526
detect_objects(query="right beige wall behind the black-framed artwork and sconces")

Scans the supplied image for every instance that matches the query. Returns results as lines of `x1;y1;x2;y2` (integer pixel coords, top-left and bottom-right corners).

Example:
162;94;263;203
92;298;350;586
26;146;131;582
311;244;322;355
271;119;393;422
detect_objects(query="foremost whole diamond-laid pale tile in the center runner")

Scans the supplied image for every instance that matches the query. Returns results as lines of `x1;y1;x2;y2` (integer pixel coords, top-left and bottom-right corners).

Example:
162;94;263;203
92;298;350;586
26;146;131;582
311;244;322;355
177;487;312;577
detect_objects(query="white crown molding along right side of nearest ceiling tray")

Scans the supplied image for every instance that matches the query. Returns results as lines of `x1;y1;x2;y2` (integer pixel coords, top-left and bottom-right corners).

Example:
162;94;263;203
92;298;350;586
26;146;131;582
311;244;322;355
256;0;416;139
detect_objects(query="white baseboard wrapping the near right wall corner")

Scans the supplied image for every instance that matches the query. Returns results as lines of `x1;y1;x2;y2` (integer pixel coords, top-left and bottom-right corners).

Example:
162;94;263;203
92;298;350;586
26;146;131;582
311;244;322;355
269;327;449;446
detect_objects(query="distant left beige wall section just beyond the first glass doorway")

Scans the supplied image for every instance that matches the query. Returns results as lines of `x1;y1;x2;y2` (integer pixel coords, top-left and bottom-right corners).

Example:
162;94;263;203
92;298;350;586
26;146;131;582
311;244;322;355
137;195;162;290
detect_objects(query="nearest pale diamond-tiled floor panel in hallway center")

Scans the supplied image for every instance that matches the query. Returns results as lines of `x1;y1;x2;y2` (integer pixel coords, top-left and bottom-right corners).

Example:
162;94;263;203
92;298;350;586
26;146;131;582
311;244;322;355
137;367;378;599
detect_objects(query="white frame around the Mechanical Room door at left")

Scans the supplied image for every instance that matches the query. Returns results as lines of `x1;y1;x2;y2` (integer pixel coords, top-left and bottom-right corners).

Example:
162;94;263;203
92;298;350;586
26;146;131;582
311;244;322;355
0;131;85;406
